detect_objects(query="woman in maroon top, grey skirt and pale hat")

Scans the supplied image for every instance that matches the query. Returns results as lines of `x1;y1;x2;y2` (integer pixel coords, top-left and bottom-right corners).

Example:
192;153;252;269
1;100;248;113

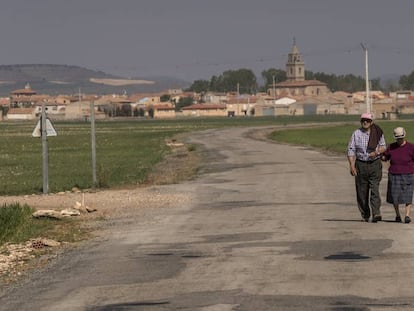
382;127;414;223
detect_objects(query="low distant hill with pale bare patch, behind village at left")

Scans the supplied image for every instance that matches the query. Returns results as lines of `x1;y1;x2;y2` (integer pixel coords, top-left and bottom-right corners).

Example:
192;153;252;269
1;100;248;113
0;64;191;96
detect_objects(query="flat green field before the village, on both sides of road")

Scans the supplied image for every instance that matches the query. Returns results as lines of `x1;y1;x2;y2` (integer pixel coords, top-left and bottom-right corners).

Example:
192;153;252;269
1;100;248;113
0;116;414;195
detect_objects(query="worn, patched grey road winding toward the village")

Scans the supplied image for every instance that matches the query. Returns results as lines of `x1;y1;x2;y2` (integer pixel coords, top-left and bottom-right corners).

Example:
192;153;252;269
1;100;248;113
0;129;414;311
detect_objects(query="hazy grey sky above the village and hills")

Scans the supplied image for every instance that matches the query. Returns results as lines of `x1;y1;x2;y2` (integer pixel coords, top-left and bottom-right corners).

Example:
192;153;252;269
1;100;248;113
0;0;414;81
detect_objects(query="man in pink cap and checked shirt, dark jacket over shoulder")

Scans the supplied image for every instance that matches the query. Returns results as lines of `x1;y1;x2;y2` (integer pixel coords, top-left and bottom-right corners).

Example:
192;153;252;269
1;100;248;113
348;113;386;222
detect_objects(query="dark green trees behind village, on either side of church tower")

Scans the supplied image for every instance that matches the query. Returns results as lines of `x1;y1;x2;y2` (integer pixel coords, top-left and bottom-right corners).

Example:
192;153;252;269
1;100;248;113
187;68;414;94
